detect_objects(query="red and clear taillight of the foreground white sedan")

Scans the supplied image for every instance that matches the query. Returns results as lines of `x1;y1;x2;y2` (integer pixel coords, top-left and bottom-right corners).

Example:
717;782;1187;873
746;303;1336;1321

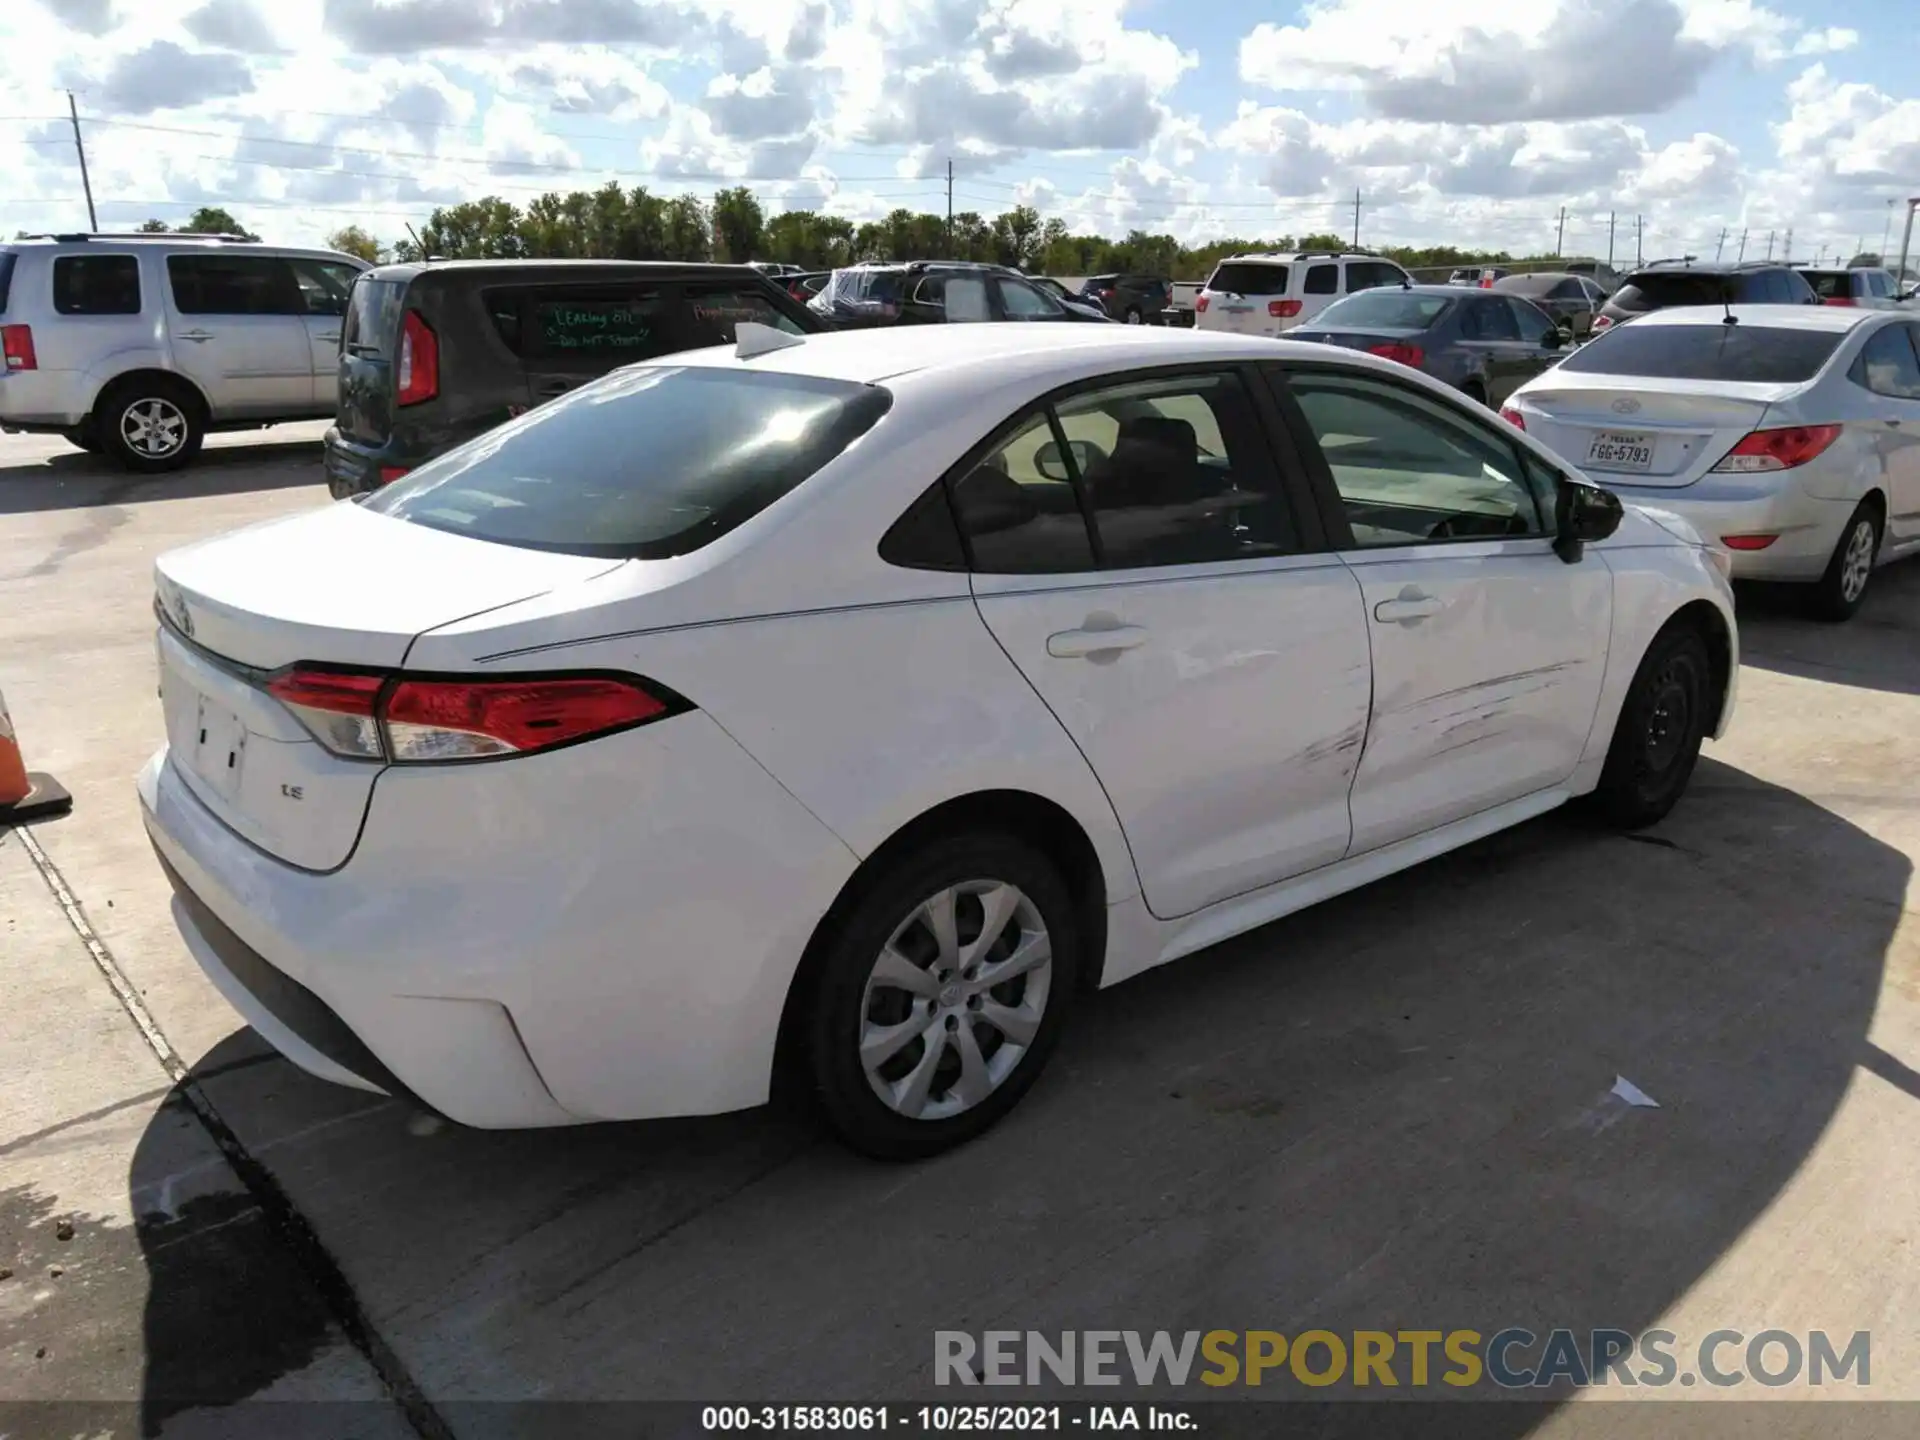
267;666;689;764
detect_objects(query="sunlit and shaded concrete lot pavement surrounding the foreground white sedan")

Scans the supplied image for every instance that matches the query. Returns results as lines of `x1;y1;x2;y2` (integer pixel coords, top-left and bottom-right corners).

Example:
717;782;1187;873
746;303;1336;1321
0;426;1920;1436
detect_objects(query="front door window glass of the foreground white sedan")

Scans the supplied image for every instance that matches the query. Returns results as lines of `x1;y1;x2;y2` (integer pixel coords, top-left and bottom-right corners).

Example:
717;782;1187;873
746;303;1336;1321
1288;374;1548;547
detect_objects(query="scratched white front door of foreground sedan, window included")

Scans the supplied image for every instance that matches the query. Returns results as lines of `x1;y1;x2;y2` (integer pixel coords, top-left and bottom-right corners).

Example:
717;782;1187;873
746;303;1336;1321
1284;367;1613;854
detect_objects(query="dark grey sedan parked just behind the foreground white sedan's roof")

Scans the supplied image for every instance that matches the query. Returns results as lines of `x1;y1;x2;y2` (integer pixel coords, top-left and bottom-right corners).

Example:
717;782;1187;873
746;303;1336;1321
1292;284;1572;407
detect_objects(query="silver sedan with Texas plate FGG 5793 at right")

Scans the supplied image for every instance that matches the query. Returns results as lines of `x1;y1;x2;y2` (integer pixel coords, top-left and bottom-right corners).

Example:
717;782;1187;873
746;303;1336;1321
1501;305;1920;620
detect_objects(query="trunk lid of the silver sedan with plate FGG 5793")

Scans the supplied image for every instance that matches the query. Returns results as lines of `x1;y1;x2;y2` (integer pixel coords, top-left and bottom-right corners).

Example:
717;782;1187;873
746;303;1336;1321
1519;371;1801;488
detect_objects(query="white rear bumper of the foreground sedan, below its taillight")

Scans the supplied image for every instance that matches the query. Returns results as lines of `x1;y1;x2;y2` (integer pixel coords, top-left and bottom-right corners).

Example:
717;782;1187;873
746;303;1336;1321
138;712;854;1129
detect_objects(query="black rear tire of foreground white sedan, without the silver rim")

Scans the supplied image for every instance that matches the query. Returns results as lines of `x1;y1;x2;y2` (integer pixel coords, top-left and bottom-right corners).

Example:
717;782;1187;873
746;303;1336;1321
803;831;1081;1160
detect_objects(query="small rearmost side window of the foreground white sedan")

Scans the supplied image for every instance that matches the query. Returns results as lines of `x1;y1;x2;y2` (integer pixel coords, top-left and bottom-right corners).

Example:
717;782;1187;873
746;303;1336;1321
952;409;1098;574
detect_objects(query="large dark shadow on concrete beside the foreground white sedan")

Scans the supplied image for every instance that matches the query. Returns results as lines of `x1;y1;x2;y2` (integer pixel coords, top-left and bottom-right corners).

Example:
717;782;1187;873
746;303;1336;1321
129;760;1920;1440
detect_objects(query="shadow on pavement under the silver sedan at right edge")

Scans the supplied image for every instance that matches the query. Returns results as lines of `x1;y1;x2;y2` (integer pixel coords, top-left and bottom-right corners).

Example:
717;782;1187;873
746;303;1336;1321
1738;559;1920;695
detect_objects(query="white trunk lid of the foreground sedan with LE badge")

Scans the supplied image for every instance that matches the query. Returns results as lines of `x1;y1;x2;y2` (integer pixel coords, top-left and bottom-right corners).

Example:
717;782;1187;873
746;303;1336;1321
154;503;618;870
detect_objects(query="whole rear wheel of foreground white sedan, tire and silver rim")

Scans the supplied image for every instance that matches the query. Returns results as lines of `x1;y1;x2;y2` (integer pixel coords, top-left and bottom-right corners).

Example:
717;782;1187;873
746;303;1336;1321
804;831;1079;1160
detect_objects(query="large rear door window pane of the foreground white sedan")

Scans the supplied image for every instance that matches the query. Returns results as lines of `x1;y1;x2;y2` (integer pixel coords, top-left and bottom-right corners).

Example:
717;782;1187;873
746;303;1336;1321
1058;372;1300;568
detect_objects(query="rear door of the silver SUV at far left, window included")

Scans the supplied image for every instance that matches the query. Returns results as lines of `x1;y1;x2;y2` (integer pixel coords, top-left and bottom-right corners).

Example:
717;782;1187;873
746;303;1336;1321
167;250;317;420
